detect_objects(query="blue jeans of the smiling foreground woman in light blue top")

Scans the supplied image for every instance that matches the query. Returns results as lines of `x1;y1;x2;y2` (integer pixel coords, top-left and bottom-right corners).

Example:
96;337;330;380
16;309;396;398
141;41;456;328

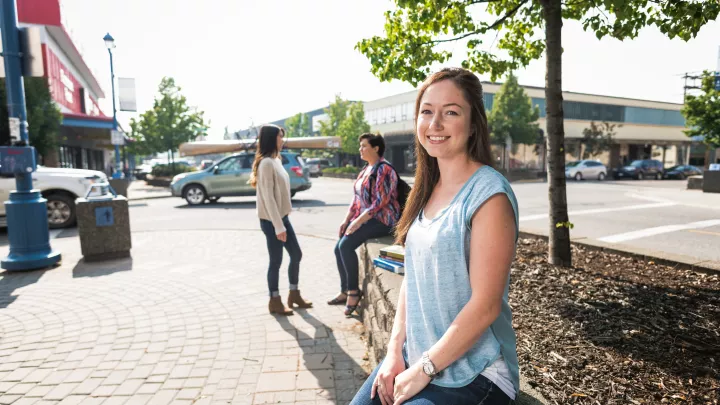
350;363;515;405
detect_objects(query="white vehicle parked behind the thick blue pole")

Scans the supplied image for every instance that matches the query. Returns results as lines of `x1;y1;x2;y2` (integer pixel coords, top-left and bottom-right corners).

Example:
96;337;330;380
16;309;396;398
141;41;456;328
0;166;107;229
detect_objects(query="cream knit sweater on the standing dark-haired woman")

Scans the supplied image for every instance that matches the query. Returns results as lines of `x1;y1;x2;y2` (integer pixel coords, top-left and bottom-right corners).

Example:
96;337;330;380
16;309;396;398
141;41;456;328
257;158;292;234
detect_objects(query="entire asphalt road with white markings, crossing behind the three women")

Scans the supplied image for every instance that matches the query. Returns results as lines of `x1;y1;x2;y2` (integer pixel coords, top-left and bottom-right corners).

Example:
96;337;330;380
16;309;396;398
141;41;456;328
0;178;720;260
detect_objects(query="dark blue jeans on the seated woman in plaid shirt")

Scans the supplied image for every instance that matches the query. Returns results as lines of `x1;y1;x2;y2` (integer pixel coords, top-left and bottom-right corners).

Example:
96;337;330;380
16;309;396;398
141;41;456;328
335;218;392;292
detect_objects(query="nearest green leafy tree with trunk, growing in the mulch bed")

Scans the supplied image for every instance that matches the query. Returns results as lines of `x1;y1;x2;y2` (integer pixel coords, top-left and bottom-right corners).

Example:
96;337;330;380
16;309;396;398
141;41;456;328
357;0;720;266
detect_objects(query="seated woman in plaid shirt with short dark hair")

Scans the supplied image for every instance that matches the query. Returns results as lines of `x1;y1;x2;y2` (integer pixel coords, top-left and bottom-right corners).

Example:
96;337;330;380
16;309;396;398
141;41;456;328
328;133;400;316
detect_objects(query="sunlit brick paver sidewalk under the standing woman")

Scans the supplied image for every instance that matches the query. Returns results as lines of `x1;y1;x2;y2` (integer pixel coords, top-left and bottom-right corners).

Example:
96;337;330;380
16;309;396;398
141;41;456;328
0;231;366;405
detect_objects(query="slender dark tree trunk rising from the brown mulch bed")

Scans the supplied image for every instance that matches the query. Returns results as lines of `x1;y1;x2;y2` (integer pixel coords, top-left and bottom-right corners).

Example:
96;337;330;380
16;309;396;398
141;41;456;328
540;0;572;266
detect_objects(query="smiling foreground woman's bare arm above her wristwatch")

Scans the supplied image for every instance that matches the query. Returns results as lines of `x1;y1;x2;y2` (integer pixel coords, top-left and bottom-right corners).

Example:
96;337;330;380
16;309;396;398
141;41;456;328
428;194;516;370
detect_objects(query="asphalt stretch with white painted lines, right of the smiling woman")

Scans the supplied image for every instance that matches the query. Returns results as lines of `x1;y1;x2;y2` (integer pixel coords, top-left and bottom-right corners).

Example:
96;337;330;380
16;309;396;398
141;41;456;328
513;181;720;260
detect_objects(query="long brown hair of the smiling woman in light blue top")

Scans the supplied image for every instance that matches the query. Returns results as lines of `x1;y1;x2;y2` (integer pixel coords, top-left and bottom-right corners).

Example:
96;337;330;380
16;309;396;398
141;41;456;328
395;68;492;245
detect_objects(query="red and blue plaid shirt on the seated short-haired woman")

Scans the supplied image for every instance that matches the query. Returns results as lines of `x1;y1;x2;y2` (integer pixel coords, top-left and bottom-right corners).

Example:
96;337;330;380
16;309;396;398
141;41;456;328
350;158;400;228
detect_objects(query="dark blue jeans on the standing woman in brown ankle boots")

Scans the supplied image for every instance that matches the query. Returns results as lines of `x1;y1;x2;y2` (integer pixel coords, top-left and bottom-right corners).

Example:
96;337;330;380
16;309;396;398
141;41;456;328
260;216;302;297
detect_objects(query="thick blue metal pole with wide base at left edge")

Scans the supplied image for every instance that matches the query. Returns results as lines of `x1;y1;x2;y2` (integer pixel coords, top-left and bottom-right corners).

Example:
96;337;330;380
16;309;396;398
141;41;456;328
0;0;60;270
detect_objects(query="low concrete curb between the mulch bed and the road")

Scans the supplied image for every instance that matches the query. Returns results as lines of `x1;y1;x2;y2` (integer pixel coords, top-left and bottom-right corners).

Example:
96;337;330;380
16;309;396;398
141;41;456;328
519;229;720;275
